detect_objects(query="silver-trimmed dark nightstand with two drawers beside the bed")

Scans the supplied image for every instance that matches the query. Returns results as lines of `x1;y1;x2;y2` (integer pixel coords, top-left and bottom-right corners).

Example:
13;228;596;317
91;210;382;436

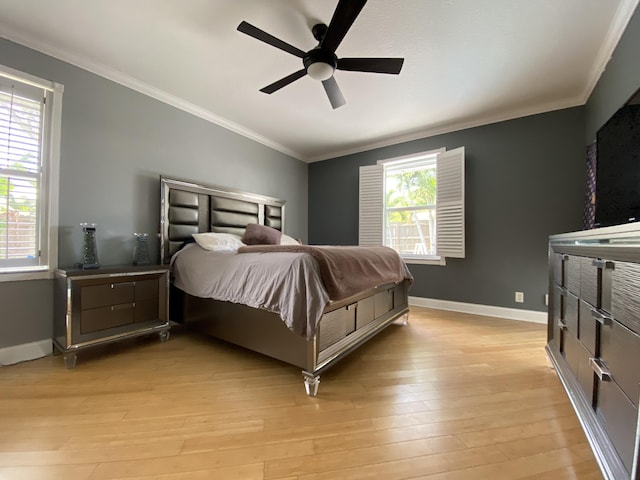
53;265;169;368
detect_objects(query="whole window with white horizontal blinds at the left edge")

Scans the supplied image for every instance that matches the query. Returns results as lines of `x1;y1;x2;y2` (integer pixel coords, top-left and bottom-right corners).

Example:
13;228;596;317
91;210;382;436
0;66;63;281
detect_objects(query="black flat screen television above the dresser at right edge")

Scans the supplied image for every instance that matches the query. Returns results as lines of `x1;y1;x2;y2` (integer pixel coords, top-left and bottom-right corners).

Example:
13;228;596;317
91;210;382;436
595;90;640;227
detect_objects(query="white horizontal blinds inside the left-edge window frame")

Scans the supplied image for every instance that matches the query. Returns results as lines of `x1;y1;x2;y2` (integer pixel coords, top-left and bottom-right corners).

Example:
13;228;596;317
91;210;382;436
0;76;45;268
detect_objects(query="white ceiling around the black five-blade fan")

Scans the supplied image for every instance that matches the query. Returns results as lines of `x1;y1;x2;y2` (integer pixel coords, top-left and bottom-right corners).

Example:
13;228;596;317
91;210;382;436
0;0;638;162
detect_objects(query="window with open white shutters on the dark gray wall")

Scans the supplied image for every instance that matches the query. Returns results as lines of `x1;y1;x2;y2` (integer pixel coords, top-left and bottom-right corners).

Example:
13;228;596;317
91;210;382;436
359;147;465;263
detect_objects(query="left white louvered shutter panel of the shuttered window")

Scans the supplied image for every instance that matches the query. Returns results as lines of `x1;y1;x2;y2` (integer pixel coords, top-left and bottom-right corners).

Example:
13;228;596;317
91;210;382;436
358;165;384;247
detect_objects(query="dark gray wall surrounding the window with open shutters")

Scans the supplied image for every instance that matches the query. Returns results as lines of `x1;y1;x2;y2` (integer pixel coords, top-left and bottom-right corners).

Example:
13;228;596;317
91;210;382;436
309;107;586;311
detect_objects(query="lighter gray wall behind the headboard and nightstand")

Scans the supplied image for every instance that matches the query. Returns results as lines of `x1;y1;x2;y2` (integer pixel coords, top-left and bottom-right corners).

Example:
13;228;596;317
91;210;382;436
0;39;307;348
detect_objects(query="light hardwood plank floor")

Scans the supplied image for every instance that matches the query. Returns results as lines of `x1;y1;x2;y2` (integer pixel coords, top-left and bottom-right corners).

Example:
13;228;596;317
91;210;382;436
0;308;602;480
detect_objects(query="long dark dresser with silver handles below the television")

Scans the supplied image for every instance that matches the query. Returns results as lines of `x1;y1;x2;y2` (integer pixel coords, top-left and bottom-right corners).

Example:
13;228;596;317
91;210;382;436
546;223;640;480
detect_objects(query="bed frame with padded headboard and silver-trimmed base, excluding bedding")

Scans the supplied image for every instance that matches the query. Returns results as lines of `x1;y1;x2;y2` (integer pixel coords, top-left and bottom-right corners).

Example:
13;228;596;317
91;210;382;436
160;177;412;396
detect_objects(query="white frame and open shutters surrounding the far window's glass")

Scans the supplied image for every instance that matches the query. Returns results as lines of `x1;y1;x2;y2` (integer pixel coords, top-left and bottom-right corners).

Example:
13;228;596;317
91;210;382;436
358;147;465;265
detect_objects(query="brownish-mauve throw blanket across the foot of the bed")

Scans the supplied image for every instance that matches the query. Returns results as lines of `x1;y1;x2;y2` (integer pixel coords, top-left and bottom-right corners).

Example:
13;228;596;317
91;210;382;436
238;245;413;301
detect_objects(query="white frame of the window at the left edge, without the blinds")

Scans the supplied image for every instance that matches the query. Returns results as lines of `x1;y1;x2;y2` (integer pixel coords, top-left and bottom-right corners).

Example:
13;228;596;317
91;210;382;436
0;65;64;282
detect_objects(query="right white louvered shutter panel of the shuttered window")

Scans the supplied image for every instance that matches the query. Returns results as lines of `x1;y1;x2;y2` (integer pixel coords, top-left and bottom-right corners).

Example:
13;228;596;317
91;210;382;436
436;147;465;258
